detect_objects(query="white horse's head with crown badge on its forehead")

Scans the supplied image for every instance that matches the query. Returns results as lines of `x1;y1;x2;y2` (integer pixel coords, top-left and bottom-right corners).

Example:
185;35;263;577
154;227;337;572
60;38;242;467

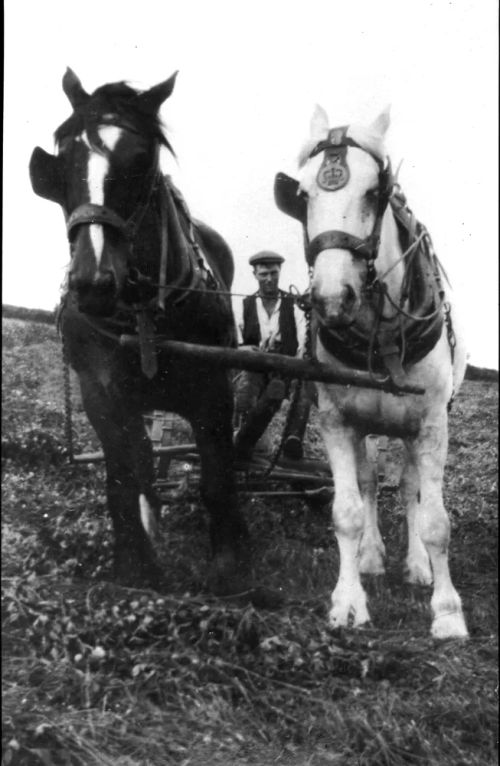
298;107;392;329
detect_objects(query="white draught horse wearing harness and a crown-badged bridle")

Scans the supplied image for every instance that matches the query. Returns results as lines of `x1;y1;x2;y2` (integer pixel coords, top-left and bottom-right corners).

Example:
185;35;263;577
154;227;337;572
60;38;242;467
275;107;467;638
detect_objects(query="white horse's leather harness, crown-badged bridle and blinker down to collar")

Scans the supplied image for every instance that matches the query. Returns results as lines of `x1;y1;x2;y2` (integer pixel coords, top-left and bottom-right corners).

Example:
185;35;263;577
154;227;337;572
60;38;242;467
274;126;453;384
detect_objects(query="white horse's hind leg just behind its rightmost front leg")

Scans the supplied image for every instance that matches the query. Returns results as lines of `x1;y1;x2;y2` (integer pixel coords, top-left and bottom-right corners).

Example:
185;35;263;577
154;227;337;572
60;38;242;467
399;444;432;585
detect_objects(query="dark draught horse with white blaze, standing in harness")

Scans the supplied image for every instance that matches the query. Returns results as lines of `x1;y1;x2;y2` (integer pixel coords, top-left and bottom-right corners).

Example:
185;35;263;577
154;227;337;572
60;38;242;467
30;69;249;593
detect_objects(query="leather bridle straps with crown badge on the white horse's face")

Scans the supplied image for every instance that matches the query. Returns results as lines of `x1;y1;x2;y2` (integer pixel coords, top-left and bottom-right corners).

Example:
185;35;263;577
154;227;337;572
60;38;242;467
305;126;394;282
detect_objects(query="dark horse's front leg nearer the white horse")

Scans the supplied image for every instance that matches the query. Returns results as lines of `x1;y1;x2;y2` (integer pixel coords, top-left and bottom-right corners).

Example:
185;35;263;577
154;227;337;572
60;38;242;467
189;375;249;595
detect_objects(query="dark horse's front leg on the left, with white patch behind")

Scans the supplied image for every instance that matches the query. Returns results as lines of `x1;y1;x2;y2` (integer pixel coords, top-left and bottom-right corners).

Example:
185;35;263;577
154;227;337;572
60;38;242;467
80;373;160;585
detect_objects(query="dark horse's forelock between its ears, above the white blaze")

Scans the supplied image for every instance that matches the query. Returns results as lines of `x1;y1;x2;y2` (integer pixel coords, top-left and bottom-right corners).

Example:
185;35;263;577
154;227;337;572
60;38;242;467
54;81;175;156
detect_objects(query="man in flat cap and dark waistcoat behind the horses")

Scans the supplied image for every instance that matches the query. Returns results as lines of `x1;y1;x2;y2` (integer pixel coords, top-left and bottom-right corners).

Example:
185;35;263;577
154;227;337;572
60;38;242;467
235;250;310;459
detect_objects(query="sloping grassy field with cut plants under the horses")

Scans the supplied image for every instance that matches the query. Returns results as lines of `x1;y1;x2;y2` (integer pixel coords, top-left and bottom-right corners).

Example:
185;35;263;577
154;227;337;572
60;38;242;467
2;320;498;766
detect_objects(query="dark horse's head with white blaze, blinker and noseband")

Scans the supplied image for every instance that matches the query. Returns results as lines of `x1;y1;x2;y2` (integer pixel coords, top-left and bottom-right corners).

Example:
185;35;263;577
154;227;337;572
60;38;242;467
30;69;177;316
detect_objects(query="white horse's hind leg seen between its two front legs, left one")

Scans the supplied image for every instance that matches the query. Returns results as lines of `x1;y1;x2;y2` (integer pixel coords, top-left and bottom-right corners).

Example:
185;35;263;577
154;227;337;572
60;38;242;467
357;436;385;575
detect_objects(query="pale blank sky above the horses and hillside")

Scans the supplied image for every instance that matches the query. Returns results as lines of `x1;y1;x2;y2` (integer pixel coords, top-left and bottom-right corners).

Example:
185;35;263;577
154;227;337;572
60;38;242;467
2;0;498;369
